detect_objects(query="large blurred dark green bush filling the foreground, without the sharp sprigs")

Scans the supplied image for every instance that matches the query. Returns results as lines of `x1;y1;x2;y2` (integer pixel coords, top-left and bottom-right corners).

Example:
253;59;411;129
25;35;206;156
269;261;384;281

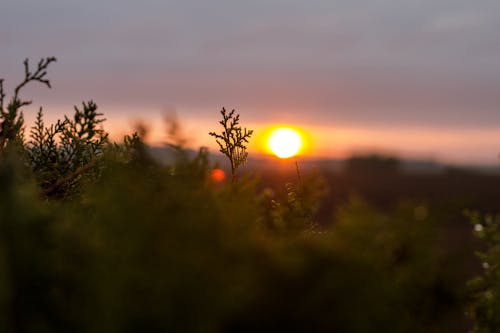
0;145;466;332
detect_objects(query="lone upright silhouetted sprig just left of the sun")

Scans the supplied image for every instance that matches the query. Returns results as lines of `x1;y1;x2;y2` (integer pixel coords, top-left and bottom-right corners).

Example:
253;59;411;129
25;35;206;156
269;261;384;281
209;108;253;182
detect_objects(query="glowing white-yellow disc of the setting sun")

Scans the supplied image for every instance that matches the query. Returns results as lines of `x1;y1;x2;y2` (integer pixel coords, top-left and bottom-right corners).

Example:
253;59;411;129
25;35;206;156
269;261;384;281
267;127;303;158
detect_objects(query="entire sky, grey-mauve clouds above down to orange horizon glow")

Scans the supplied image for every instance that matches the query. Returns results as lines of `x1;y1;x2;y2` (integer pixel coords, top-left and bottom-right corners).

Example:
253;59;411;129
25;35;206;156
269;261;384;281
0;0;500;165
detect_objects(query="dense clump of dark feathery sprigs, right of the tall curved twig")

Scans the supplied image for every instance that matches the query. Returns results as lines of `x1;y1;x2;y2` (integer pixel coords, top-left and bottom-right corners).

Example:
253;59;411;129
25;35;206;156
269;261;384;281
25;101;108;196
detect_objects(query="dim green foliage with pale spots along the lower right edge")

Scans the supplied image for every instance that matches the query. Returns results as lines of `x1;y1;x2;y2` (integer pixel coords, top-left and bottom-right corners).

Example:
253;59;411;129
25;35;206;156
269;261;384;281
468;213;500;333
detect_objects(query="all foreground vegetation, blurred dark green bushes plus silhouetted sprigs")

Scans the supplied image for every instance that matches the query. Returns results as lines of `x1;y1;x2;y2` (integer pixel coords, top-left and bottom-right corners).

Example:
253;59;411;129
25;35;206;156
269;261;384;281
0;58;500;332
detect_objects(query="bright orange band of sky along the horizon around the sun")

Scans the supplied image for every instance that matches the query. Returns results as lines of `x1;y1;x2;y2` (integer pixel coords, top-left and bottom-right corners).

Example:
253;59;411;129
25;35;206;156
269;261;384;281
47;107;500;165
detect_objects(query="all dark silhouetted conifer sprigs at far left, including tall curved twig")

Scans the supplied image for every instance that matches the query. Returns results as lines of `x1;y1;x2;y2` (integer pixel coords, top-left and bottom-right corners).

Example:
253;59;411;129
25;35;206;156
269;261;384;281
0;57;156;198
